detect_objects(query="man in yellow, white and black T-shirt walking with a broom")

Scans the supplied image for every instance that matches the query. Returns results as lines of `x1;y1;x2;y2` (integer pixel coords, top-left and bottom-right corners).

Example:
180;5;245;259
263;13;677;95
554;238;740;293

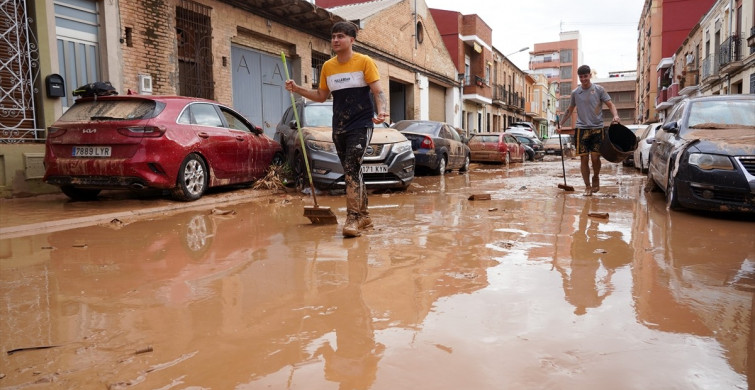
286;22;388;237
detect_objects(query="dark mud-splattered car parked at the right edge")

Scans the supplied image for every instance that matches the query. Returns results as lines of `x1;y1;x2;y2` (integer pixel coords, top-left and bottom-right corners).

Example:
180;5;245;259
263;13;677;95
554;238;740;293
648;95;755;213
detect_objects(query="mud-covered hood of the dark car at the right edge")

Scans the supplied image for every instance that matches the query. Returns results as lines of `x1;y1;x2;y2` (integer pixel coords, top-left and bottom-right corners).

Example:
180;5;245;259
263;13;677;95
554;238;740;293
682;128;755;156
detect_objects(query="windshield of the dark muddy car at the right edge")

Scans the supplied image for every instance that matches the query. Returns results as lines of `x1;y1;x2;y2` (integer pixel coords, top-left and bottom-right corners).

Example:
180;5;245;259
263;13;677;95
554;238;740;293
687;100;755;129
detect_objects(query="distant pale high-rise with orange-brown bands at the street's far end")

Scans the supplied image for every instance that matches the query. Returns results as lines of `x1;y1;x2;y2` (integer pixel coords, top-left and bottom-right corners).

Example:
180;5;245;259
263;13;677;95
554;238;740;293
529;31;582;134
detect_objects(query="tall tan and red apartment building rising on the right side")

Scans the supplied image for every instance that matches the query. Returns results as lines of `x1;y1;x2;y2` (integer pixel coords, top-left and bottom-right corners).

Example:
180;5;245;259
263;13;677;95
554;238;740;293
636;0;714;123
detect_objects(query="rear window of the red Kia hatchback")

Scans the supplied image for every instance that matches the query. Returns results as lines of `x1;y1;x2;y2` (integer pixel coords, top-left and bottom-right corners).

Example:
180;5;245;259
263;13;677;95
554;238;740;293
59;99;164;122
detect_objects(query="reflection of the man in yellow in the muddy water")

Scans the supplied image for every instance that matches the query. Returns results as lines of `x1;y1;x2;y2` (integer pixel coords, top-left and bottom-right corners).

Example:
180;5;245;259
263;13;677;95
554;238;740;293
317;240;385;389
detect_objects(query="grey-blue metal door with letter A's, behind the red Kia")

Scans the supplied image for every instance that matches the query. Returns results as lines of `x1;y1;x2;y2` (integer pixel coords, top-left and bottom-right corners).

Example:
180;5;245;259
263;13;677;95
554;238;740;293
231;46;291;138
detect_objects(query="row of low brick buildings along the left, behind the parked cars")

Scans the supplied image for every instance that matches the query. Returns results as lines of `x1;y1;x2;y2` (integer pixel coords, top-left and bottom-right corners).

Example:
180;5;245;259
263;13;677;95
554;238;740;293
0;0;461;197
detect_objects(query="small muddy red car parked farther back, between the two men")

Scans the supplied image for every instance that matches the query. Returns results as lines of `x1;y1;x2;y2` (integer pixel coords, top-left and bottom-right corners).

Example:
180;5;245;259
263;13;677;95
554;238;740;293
469;133;527;165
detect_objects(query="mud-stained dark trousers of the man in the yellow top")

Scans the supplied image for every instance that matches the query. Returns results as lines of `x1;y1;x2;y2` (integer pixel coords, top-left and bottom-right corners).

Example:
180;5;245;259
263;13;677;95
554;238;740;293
333;127;372;218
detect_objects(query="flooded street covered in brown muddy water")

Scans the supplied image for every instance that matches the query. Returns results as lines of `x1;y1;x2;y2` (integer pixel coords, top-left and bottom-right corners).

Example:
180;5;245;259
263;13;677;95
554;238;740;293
0;157;755;390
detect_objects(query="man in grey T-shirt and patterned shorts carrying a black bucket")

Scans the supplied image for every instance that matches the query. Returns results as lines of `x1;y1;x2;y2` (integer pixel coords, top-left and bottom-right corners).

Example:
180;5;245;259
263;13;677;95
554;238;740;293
560;65;619;196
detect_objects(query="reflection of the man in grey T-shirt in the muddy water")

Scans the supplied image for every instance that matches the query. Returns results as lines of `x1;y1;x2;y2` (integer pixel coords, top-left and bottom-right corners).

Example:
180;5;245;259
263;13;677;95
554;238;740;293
554;198;632;315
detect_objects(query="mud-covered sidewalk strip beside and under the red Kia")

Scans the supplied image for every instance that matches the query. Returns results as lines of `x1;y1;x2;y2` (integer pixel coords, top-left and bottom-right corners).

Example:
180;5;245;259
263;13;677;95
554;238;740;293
0;189;281;239
